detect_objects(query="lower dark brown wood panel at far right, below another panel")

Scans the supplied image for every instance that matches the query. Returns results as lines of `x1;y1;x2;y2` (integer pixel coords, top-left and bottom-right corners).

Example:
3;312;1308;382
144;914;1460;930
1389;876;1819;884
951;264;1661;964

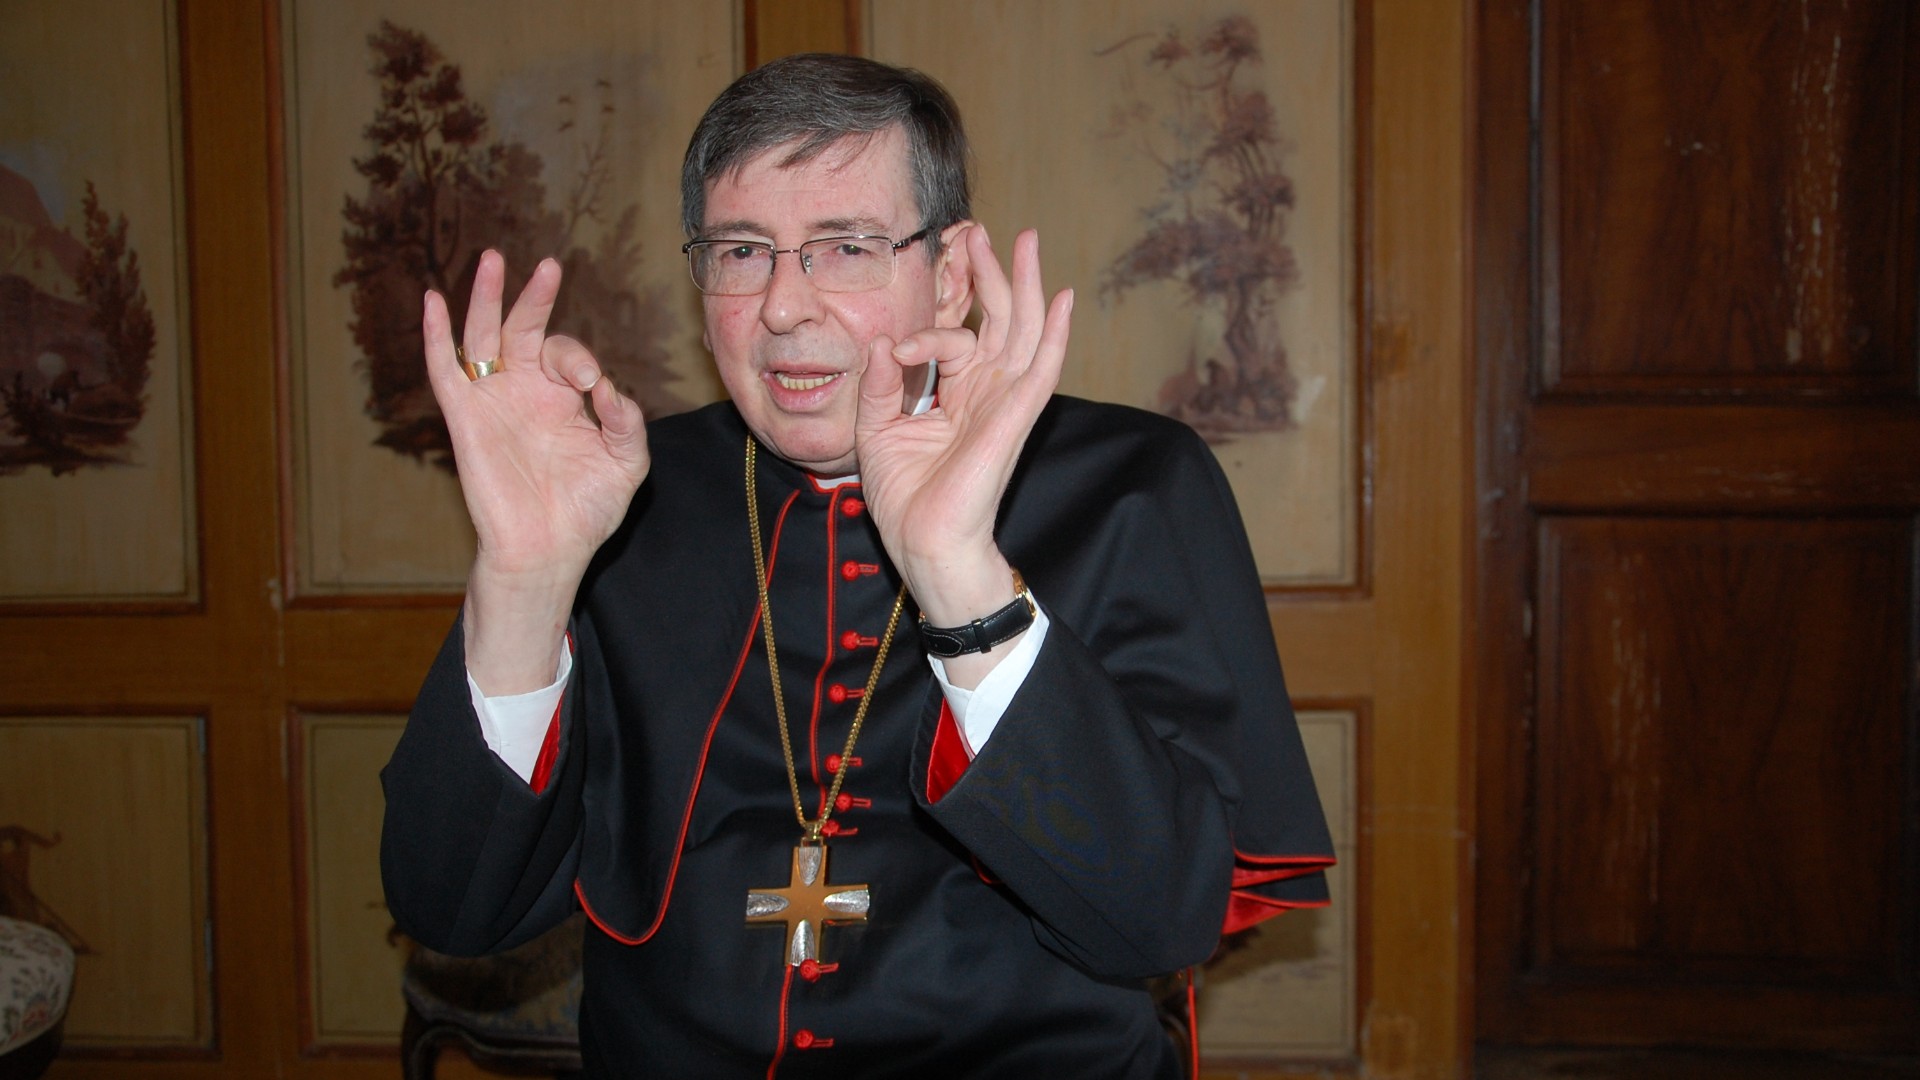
1526;517;1914;990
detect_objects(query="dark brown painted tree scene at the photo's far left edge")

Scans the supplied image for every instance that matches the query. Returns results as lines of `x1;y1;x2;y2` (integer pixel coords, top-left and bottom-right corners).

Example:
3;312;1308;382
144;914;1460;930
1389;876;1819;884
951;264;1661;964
0;165;156;477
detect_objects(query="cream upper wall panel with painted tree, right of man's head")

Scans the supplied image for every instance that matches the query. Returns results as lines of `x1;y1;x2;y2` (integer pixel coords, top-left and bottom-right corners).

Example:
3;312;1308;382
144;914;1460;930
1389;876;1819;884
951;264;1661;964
868;0;1367;592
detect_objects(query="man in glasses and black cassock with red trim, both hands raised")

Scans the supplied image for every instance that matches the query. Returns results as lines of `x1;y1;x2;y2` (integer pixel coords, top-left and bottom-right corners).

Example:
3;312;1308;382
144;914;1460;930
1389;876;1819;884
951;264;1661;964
382;56;1331;1078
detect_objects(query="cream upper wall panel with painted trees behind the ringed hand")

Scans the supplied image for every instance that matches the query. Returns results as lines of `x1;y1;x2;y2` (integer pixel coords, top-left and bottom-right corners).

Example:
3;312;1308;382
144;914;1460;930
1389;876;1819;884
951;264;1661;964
278;0;735;591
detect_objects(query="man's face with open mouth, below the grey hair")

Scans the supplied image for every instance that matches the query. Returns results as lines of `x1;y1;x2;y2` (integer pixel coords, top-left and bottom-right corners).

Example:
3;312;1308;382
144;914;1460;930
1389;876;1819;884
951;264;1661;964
701;129;966;477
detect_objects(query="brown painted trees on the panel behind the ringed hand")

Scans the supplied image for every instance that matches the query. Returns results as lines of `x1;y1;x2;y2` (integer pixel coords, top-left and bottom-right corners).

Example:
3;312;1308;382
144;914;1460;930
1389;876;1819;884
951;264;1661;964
334;21;689;467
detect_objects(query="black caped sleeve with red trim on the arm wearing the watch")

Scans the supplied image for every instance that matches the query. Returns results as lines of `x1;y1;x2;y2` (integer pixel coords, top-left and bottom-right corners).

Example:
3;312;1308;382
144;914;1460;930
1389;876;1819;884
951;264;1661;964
914;403;1332;978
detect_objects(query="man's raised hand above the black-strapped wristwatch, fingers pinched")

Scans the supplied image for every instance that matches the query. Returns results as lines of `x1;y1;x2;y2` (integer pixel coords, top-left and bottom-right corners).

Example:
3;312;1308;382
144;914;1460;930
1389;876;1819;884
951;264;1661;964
854;225;1073;684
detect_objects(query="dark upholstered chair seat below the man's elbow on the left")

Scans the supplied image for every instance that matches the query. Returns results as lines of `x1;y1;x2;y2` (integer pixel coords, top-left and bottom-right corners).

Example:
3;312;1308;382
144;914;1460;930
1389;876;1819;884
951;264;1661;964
401;915;586;1080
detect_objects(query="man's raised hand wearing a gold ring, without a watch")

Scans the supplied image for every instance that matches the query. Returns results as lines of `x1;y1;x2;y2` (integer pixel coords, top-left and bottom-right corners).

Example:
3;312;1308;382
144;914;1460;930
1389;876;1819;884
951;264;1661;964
422;252;649;696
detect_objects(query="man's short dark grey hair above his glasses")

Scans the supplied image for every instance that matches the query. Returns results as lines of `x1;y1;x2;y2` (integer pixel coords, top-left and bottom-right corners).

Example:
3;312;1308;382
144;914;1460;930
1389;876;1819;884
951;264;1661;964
680;52;973;258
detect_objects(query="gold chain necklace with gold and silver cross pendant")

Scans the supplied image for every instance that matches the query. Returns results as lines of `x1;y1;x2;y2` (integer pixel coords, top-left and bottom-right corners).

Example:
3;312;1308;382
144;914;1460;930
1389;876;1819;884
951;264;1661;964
747;434;906;978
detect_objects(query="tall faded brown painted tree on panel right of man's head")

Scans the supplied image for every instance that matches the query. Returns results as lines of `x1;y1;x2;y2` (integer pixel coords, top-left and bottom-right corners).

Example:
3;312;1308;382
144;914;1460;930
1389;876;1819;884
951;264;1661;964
1102;15;1300;440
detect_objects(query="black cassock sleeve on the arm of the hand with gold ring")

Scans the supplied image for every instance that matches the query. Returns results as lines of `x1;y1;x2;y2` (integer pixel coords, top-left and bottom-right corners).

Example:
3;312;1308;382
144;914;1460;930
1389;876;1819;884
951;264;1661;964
380;619;584;955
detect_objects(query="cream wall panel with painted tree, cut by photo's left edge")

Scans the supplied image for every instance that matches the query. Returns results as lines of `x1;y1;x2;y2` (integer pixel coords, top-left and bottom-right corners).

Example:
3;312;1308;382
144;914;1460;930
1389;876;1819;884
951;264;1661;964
0;0;200;595
